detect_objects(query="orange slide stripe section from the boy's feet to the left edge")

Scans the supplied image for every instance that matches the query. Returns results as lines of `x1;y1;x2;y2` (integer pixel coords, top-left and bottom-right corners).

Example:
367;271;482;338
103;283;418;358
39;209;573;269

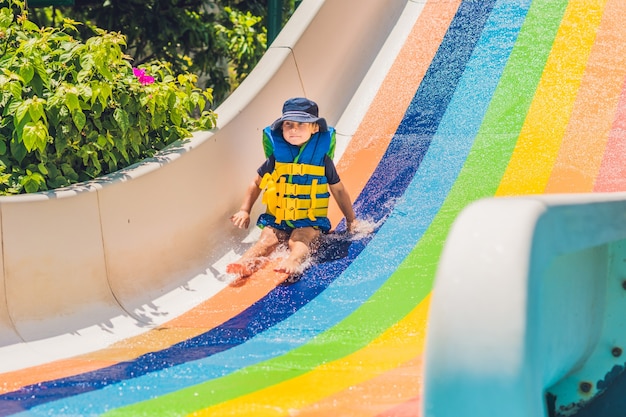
0;261;285;394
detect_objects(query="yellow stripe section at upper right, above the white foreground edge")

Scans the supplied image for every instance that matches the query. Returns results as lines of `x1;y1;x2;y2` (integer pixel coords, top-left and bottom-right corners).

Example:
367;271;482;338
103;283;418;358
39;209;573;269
496;0;606;196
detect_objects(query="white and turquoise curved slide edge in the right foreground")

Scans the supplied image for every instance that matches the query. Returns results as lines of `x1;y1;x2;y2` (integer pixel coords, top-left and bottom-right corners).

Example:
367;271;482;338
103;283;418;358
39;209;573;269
423;193;626;417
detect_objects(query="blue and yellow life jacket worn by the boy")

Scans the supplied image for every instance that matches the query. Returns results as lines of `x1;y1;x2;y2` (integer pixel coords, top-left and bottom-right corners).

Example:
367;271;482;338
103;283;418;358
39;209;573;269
260;127;335;227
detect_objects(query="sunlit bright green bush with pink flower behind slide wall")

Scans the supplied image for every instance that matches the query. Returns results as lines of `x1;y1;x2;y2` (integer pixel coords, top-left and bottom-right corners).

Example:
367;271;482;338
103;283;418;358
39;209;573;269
0;0;216;195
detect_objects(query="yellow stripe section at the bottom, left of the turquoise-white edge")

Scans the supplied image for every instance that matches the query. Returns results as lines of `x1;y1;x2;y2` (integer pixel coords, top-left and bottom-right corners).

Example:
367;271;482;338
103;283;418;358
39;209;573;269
191;295;430;417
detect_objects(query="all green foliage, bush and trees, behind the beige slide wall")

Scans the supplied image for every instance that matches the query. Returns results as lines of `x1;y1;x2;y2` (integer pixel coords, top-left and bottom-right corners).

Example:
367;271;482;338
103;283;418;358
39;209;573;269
0;0;295;195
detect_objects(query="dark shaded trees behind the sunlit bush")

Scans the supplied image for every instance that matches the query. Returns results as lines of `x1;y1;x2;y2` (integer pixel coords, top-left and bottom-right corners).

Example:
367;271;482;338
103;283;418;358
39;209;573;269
29;0;295;104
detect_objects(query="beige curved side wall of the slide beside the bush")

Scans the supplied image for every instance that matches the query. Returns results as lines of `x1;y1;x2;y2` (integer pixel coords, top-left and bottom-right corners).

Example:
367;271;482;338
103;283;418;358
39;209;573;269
0;0;412;372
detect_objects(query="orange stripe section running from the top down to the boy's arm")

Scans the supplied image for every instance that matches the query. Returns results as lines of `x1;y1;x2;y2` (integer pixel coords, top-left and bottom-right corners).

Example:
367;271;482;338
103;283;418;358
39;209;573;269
328;0;461;224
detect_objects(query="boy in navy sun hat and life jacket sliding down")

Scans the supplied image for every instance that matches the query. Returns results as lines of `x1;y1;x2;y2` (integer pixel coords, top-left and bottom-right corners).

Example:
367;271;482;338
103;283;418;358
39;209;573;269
226;97;356;277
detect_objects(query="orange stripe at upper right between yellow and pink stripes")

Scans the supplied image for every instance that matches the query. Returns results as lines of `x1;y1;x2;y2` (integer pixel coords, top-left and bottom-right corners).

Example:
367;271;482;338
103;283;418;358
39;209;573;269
545;0;626;193
